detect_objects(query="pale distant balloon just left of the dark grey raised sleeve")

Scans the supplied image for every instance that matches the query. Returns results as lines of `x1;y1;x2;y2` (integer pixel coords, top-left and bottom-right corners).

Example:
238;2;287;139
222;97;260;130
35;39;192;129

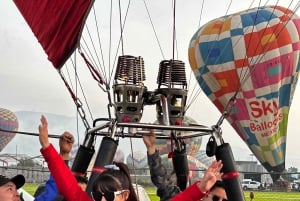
126;151;148;168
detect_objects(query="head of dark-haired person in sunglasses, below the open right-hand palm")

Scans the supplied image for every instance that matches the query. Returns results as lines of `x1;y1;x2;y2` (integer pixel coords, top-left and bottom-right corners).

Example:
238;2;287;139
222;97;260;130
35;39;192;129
203;180;227;201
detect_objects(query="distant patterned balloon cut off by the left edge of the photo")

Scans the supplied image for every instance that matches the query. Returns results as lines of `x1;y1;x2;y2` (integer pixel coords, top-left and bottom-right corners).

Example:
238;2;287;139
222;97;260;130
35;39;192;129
0;108;19;152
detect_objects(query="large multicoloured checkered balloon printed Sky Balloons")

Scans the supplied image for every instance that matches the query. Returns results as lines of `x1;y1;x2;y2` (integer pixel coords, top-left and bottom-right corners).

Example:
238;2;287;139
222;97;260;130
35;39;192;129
189;6;300;179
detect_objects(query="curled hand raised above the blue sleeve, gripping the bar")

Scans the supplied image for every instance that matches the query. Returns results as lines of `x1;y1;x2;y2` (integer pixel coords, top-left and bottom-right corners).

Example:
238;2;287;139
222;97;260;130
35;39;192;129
59;131;74;160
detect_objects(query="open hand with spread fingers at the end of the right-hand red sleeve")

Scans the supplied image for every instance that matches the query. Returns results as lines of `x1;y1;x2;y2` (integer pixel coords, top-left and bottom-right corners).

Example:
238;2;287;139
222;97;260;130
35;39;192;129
198;160;223;192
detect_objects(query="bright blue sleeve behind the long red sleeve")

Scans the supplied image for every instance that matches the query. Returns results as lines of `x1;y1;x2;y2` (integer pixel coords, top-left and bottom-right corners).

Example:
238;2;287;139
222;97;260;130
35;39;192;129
34;175;58;201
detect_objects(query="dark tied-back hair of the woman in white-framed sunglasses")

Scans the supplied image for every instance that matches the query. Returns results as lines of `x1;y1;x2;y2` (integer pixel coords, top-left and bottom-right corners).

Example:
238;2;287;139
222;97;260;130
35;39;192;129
93;162;138;201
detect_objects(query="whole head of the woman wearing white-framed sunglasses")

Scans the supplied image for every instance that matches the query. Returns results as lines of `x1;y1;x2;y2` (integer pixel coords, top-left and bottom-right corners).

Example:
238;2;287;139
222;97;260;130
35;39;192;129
92;163;137;201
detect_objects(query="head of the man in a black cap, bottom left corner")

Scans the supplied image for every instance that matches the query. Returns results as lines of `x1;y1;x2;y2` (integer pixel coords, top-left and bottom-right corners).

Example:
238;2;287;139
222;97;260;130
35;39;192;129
0;175;25;201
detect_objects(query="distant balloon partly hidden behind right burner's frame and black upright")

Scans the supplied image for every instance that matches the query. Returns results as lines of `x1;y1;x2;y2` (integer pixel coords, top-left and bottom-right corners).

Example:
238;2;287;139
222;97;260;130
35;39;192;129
155;116;202;156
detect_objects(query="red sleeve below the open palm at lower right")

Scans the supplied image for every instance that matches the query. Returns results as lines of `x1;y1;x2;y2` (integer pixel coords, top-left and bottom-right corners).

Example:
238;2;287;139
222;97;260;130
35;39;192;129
171;181;207;201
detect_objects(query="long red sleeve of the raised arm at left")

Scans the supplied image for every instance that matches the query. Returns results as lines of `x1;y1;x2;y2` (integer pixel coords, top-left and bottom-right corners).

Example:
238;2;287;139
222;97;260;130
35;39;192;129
40;144;92;201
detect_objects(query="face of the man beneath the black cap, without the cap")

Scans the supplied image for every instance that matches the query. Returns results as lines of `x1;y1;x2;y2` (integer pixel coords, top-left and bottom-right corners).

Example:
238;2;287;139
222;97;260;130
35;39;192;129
0;182;21;201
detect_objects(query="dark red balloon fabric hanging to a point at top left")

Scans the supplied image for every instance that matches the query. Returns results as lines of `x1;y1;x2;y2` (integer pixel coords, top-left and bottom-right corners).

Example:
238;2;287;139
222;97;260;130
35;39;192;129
14;0;94;69
